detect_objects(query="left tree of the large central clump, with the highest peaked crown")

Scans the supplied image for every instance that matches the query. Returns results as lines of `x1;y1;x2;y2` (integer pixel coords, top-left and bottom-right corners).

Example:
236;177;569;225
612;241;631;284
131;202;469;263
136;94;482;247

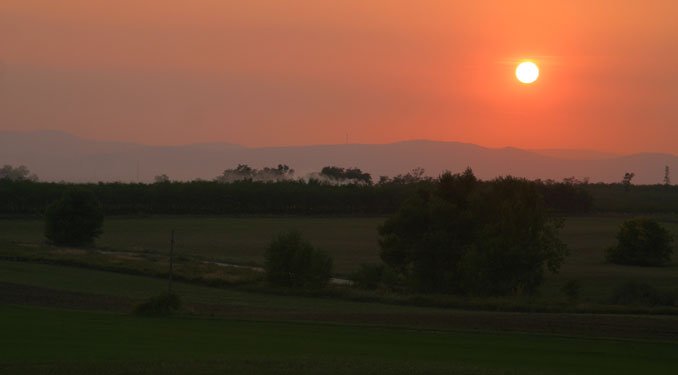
380;170;478;292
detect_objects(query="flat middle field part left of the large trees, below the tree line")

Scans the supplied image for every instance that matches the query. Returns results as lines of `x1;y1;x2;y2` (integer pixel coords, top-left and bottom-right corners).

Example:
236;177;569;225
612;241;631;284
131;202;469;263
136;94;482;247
0;216;384;273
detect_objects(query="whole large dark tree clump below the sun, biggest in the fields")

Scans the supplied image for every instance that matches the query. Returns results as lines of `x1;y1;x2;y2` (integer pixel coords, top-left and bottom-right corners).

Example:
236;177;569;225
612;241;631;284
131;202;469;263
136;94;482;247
380;169;566;295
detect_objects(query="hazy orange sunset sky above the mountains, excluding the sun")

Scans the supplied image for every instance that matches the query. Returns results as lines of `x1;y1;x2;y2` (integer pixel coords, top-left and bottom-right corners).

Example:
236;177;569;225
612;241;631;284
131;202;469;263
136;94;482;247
0;0;678;153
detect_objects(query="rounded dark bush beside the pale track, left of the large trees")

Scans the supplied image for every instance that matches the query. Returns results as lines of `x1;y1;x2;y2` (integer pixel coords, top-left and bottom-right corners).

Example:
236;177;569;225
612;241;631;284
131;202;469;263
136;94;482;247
265;231;332;288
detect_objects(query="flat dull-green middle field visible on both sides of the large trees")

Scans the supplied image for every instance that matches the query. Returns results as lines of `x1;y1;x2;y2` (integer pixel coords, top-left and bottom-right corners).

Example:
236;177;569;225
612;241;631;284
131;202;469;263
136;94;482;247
0;216;678;303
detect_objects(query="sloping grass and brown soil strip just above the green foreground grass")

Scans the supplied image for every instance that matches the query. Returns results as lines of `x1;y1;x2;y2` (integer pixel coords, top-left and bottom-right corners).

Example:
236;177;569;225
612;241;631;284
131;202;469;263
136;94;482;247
5;261;678;339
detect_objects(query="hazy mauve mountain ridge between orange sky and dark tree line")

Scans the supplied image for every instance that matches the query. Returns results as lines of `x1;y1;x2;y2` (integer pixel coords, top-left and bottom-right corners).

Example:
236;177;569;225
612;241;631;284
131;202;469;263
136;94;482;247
0;131;678;184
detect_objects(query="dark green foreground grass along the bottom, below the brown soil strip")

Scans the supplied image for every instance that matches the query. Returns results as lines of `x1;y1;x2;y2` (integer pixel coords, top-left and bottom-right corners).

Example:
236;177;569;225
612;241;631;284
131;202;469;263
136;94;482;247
0;306;678;374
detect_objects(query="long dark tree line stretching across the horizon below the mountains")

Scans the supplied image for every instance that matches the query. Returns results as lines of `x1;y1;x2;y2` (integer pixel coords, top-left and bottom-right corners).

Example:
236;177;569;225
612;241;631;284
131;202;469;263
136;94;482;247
0;164;678;215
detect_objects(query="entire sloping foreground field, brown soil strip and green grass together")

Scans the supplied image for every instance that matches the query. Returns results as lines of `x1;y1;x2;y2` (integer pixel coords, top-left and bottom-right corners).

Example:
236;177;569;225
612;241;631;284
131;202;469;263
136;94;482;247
0;262;678;374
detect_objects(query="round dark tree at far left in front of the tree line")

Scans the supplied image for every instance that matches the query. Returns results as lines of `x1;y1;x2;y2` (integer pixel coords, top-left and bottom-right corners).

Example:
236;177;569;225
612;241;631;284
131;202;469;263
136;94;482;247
45;189;104;246
